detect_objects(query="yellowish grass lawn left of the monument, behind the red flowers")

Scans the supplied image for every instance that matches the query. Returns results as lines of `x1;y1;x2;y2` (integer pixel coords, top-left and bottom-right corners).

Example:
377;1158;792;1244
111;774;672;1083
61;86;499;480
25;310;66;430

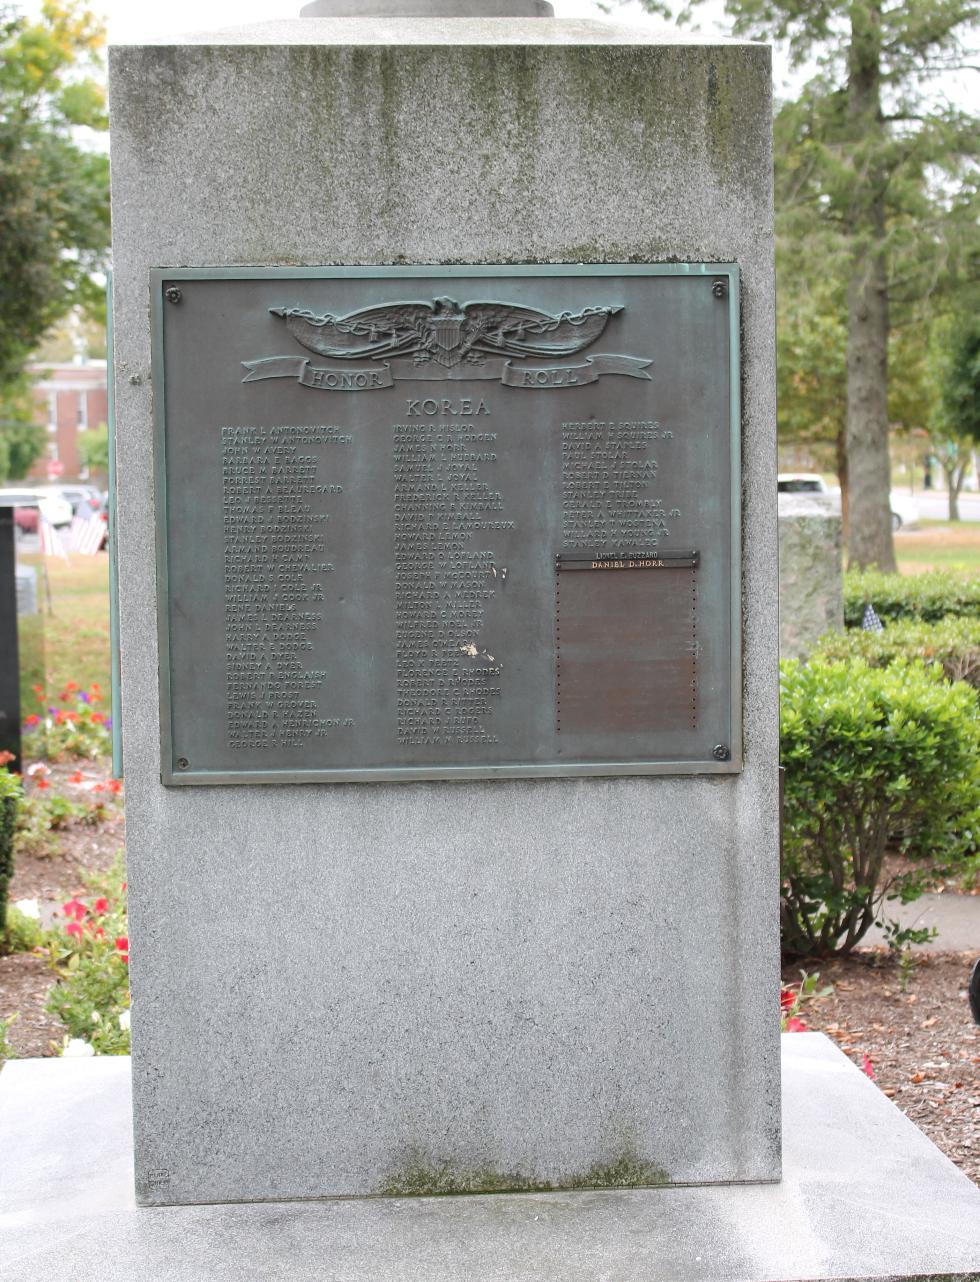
18;553;110;715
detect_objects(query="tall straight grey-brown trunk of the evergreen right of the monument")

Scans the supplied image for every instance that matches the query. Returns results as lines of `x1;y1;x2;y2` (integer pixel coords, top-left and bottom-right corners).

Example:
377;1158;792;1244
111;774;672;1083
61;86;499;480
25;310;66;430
847;0;895;570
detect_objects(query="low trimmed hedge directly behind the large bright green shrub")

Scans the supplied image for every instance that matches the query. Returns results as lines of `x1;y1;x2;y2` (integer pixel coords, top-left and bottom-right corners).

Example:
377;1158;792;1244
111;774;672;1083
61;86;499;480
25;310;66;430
812;615;980;687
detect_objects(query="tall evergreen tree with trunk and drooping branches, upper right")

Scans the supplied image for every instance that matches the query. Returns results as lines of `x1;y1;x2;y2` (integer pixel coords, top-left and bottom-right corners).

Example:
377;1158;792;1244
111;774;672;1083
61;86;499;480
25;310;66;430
631;0;980;569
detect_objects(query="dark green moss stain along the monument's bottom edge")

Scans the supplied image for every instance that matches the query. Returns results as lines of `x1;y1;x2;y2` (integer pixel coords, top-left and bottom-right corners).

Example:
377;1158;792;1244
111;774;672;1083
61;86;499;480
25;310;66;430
376;1145;670;1197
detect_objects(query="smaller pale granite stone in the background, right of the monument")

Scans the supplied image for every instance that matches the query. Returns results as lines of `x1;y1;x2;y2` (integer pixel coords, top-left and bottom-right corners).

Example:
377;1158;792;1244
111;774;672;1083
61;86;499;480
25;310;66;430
779;494;844;659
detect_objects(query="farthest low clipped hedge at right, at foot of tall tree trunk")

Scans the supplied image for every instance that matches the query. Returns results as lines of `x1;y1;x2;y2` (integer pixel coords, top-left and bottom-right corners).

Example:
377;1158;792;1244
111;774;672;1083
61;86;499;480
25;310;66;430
844;569;980;628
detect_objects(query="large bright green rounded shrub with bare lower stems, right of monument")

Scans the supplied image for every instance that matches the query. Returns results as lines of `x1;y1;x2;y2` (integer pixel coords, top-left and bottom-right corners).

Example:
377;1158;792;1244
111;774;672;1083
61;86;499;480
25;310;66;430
780;659;980;956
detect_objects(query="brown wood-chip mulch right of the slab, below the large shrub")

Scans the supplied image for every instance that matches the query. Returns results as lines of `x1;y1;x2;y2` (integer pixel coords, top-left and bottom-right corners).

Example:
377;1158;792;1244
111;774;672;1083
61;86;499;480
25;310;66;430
782;950;980;1183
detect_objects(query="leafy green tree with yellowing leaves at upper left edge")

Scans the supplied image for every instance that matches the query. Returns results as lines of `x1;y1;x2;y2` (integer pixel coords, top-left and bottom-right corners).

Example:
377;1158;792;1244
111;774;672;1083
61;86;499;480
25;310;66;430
0;0;109;390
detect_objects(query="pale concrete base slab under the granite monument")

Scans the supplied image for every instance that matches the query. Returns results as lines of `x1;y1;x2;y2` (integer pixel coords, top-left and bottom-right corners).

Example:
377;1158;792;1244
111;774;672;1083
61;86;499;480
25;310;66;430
0;1033;980;1282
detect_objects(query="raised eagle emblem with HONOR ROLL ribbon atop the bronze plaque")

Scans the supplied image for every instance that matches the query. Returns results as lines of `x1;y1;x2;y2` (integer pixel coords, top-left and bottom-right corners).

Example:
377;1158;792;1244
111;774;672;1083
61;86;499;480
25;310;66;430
242;297;653;391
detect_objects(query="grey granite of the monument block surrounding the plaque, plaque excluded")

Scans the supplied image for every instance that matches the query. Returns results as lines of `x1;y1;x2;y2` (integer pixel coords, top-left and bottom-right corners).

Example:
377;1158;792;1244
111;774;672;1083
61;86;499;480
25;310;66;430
110;18;780;1205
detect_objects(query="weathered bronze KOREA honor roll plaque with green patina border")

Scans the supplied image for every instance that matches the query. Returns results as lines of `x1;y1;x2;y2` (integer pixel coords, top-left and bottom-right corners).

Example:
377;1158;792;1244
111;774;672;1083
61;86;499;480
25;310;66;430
151;264;740;783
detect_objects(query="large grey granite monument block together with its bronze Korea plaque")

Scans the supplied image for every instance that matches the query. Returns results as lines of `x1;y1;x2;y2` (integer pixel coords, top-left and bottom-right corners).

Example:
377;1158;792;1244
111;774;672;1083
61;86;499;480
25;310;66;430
110;6;780;1204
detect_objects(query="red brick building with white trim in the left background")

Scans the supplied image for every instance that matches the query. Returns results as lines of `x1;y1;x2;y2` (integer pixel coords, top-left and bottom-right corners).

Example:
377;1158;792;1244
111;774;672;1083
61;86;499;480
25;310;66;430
31;360;109;481
